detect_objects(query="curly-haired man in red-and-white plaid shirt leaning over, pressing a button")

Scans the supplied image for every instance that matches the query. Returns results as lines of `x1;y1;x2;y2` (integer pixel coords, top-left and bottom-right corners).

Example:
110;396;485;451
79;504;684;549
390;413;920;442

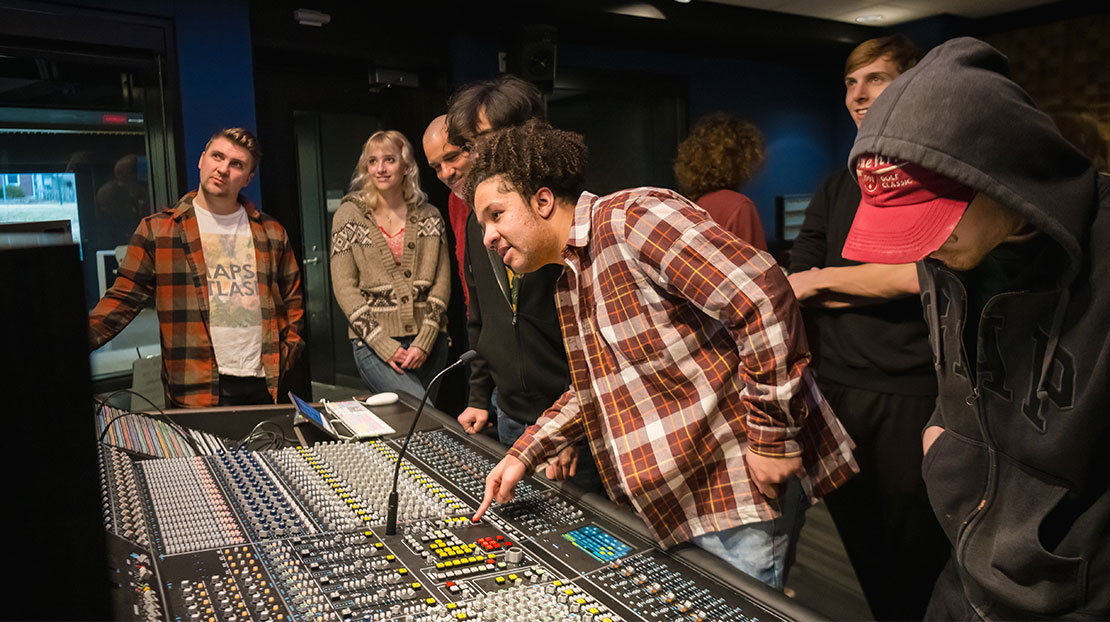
466;121;857;588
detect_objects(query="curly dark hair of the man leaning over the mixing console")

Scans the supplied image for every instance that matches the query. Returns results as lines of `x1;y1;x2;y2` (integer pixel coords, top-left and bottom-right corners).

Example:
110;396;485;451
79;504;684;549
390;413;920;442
463;119;587;205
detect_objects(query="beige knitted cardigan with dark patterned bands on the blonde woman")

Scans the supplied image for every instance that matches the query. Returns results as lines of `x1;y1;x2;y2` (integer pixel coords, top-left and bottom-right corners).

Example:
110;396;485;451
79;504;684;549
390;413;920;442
331;194;451;361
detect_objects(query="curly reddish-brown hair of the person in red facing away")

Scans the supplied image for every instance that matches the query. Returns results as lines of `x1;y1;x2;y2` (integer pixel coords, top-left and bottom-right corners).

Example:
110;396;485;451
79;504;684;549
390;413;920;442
675;112;766;200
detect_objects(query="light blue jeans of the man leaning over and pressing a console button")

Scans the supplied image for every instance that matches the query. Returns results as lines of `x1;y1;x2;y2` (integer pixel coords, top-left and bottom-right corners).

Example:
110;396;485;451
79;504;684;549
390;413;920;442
694;479;809;590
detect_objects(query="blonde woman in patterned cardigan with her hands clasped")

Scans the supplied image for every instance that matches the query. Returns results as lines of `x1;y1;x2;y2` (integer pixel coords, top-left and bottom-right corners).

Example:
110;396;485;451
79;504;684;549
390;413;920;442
332;131;451;399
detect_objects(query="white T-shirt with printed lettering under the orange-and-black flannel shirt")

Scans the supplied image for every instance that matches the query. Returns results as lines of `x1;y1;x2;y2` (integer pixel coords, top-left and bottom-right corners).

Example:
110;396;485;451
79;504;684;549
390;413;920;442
193;202;265;377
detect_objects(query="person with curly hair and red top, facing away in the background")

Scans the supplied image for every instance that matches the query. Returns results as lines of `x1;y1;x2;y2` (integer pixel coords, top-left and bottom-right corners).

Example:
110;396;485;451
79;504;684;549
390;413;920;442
675;112;767;251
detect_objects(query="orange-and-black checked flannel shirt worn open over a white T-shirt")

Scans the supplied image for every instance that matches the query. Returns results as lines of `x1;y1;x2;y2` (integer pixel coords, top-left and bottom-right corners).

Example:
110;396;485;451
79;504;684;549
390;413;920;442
89;191;304;408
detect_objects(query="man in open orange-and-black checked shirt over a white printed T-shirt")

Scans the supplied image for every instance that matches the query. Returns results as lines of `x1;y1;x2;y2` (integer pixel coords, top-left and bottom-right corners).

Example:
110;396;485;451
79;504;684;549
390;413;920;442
89;128;304;408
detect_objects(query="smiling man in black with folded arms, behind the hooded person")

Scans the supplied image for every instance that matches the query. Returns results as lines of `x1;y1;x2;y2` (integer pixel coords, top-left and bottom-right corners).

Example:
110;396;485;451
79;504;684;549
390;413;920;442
790;34;948;620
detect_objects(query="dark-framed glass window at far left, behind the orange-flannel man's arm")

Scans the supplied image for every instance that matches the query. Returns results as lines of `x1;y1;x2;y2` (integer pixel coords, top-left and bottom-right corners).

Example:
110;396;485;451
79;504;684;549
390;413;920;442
0;42;178;379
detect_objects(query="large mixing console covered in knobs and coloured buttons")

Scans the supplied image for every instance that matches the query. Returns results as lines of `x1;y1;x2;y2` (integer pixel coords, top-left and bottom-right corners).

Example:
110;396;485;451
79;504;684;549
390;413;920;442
101;413;803;622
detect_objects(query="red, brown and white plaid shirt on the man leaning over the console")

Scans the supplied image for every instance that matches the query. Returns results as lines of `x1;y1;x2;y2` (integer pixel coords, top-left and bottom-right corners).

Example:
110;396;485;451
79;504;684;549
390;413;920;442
509;188;857;546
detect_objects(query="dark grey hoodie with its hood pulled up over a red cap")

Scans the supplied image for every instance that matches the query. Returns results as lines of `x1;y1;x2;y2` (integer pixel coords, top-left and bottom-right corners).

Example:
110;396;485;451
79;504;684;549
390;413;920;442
849;38;1110;619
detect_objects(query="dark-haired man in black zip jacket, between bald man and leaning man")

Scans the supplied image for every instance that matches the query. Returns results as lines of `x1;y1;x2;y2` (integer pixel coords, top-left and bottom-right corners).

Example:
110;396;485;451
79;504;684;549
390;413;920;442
447;74;602;491
